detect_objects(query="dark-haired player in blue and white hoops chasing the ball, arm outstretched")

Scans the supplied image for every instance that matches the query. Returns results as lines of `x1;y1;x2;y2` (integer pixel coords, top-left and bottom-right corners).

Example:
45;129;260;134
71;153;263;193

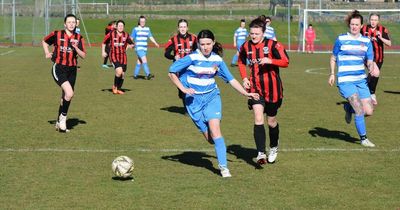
168;30;259;177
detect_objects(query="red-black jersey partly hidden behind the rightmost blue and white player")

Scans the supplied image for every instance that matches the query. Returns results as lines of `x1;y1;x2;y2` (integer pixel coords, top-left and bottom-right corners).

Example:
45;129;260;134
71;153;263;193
361;25;390;63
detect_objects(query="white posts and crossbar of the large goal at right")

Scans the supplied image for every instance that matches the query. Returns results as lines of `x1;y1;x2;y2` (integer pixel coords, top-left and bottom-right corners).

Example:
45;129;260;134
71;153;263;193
302;9;400;54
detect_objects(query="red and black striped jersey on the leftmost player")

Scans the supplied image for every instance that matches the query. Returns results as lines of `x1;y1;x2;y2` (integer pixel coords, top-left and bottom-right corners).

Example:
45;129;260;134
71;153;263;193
43;30;86;66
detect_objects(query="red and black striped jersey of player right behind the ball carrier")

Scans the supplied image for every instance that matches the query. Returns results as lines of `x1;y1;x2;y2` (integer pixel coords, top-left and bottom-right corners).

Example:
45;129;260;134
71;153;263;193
238;39;289;103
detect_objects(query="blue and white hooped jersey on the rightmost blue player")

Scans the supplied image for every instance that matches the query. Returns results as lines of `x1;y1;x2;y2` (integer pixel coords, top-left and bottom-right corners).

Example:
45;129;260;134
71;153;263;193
333;33;374;84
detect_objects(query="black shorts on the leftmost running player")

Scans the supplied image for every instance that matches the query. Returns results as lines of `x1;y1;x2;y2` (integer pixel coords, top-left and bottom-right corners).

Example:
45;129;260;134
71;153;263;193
51;63;76;89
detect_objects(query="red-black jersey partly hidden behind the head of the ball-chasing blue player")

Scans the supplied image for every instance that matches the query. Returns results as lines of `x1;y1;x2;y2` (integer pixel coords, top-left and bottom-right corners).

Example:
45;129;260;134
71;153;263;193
164;33;197;60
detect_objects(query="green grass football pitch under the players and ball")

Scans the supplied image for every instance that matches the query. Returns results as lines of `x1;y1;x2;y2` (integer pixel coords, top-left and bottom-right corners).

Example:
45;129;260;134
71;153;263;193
0;47;400;209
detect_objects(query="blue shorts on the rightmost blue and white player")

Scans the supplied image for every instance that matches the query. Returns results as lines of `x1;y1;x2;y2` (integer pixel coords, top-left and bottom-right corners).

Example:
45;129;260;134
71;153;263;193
338;80;371;99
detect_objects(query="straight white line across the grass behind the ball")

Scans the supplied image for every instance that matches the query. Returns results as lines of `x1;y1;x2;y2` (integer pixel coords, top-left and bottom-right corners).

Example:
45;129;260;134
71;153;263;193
0;147;400;153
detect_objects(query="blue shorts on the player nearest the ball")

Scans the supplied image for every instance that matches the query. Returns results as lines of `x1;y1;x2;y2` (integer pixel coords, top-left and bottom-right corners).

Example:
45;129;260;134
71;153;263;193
185;89;222;133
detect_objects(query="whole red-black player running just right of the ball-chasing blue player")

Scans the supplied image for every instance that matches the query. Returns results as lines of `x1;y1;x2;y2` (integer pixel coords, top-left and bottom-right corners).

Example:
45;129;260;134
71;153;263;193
238;18;289;165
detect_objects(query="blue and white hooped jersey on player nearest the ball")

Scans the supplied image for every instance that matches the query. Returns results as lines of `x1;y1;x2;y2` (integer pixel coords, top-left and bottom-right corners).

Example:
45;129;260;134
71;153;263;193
169;49;234;94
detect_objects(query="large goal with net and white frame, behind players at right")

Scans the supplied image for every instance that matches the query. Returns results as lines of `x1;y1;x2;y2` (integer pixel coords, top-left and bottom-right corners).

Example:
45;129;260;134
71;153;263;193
298;9;400;53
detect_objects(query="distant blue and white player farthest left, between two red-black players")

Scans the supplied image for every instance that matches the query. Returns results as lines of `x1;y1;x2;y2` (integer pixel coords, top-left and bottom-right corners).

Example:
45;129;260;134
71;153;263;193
131;16;160;80
